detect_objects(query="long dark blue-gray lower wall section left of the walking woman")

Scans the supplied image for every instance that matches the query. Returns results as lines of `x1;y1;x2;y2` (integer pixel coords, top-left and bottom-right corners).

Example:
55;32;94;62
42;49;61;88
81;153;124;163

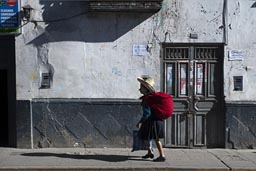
32;99;140;148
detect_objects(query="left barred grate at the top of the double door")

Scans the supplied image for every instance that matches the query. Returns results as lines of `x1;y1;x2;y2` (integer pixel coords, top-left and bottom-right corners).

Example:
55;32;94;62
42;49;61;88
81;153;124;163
165;48;189;59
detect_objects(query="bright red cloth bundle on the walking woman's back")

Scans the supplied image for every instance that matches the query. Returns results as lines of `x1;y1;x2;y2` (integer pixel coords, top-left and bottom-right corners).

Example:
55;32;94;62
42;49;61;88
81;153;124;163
143;92;173;120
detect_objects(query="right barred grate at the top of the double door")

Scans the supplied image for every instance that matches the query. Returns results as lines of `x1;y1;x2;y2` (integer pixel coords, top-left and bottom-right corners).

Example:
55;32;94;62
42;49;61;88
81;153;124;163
195;47;217;59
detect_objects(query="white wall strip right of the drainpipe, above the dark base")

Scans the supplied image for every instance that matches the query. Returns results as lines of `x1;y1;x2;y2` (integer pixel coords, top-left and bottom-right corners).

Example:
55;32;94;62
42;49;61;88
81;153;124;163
224;0;256;101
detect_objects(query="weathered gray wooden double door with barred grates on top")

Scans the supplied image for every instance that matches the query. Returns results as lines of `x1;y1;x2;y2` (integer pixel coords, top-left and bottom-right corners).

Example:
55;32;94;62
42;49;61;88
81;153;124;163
162;45;224;148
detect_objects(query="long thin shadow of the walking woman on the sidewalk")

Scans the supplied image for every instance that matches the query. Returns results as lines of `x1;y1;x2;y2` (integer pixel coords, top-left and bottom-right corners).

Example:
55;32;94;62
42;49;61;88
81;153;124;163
20;153;142;162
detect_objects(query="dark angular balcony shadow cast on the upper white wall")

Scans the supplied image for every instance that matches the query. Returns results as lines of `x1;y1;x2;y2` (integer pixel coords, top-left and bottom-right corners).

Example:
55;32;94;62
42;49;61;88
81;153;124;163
28;0;156;46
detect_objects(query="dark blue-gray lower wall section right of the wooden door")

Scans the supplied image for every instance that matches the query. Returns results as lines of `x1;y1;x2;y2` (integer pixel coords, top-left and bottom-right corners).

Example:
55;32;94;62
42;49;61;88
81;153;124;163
226;102;256;149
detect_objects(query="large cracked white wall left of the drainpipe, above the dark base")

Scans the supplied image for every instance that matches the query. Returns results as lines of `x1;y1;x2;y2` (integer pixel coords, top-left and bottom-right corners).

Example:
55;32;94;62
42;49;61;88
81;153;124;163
16;0;236;100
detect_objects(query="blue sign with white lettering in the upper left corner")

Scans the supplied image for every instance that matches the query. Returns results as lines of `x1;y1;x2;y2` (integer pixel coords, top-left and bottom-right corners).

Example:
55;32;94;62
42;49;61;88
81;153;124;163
0;0;20;34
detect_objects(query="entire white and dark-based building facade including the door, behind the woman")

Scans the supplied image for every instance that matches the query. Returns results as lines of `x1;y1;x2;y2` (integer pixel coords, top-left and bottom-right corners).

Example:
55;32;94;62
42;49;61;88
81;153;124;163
1;0;256;148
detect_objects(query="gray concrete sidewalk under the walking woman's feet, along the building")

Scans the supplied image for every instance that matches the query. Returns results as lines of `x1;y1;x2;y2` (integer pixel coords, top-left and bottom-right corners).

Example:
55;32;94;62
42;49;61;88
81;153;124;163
0;148;256;171
